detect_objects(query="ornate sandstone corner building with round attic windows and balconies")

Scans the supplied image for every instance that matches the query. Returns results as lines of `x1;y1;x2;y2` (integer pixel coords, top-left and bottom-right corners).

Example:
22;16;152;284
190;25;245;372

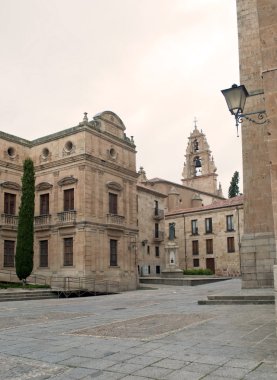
0;111;138;290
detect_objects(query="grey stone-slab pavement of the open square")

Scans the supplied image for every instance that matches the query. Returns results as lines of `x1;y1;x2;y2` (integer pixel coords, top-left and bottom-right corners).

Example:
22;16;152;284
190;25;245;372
0;279;277;380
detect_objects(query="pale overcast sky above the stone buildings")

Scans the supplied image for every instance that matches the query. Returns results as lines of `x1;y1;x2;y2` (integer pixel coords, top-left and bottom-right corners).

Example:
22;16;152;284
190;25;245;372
0;0;239;196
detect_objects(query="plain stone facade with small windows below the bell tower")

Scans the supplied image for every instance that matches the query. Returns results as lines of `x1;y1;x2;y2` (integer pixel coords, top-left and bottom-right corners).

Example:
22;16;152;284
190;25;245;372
166;196;243;277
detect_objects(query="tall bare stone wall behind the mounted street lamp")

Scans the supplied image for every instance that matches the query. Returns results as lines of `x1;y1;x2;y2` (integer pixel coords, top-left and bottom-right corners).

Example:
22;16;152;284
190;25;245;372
237;0;277;288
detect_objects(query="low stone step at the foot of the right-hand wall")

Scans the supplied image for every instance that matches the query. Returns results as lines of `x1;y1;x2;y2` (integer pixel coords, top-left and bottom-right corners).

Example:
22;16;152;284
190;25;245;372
198;295;275;305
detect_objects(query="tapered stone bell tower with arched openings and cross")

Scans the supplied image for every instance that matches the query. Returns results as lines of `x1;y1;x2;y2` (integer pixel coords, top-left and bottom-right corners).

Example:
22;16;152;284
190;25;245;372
182;119;222;196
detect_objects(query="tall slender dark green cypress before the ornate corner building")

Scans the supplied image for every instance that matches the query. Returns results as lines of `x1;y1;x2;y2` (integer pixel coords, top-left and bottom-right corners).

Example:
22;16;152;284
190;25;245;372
15;158;35;283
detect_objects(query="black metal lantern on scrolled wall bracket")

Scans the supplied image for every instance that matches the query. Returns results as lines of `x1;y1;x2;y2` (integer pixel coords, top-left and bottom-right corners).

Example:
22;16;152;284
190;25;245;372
221;84;268;135
